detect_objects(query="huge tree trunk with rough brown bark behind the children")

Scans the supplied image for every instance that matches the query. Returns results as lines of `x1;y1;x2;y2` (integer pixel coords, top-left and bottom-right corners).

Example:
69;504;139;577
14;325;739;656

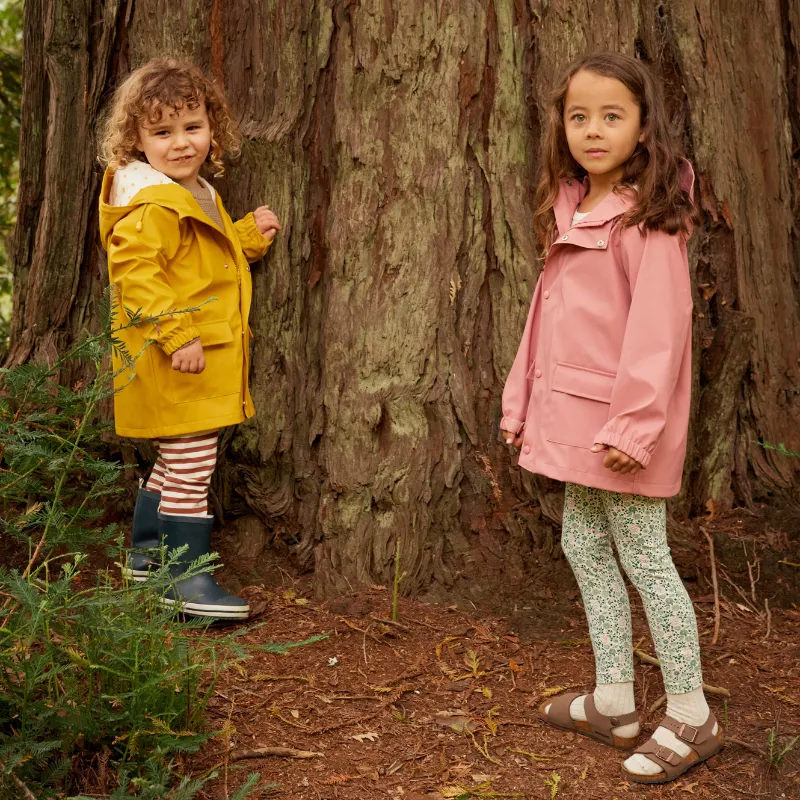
9;0;800;594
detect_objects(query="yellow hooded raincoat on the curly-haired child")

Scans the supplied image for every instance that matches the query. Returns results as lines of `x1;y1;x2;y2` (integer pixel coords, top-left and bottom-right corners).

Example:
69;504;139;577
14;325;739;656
100;165;269;439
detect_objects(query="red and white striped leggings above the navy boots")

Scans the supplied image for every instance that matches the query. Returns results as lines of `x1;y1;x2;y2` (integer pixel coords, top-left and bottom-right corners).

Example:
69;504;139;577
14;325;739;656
145;431;219;516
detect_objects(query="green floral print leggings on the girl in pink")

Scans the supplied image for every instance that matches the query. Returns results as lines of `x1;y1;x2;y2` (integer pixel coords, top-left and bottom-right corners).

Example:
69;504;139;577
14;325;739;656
561;483;703;694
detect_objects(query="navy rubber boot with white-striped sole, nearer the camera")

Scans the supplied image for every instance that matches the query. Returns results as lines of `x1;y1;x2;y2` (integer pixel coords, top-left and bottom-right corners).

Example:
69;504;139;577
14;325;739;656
158;511;250;621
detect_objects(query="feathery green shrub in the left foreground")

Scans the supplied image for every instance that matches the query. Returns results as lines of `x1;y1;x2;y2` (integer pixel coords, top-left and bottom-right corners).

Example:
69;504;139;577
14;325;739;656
0;296;312;800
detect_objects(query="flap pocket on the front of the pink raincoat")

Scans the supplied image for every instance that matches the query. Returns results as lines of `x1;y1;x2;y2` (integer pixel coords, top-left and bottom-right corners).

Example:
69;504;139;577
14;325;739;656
545;362;616;450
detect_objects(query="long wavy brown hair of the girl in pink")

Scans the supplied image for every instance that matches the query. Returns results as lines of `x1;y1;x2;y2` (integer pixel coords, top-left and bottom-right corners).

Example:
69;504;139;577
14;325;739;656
533;53;694;254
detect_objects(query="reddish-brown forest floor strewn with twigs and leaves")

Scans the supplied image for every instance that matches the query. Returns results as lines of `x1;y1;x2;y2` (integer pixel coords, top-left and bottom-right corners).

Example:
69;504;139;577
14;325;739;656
184;510;800;800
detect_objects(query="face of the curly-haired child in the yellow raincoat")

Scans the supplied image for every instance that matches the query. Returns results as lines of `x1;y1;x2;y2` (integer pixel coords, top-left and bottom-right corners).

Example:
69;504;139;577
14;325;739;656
136;103;211;186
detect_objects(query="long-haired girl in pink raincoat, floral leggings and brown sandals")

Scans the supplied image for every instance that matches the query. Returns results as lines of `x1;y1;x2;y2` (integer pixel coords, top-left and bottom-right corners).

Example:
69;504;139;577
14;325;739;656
500;54;724;783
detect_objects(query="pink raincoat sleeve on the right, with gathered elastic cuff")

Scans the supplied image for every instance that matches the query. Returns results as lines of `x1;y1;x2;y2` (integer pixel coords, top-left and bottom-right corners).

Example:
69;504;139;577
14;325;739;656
594;228;692;468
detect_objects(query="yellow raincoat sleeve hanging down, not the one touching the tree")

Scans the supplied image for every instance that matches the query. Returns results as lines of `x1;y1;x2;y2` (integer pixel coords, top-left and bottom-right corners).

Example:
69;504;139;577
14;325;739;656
108;205;200;355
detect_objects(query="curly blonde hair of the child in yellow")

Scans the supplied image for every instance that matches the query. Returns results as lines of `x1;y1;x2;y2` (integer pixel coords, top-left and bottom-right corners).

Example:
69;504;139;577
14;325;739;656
99;58;240;176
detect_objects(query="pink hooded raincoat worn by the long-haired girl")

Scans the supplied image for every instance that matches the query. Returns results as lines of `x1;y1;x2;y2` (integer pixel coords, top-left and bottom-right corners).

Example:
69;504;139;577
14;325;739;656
500;162;694;497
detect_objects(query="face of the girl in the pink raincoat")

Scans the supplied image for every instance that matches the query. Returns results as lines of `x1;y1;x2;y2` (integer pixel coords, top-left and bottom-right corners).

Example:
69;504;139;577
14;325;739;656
564;70;643;186
